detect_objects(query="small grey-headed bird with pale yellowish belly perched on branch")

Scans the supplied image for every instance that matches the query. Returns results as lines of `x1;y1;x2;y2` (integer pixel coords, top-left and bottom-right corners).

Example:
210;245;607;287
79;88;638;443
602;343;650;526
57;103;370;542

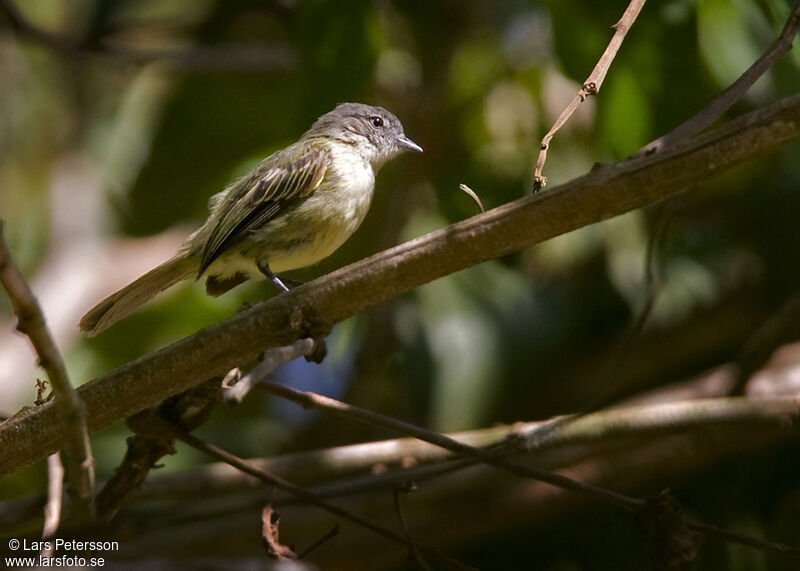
80;103;422;337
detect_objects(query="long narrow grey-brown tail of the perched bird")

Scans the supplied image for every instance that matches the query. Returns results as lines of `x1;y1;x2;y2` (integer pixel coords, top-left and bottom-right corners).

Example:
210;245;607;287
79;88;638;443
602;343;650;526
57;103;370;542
80;254;197;337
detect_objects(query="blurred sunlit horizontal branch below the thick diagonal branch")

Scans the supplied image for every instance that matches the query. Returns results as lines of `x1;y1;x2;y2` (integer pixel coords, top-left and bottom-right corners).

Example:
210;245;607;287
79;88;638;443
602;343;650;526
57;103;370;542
131;396;800;499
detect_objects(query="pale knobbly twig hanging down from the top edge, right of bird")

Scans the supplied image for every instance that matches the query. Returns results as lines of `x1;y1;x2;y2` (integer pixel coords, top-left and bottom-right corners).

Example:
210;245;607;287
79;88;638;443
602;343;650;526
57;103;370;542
533;0;646;192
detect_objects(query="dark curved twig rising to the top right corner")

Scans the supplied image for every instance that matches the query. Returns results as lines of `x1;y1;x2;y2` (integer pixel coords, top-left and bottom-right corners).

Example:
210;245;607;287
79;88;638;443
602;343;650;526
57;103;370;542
634;2;800;156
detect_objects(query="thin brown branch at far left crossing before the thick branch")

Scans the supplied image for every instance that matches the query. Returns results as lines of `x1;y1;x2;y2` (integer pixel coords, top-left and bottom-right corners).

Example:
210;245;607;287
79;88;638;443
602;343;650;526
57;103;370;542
0;220;95;525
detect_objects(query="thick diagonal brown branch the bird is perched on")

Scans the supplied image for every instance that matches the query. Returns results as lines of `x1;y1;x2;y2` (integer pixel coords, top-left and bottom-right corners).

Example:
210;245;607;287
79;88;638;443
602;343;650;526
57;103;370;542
0;91;800;477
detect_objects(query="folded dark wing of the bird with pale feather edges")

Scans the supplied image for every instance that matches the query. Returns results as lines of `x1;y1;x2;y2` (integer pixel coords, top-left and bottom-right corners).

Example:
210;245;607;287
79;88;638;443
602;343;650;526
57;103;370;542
197;144;328;277
